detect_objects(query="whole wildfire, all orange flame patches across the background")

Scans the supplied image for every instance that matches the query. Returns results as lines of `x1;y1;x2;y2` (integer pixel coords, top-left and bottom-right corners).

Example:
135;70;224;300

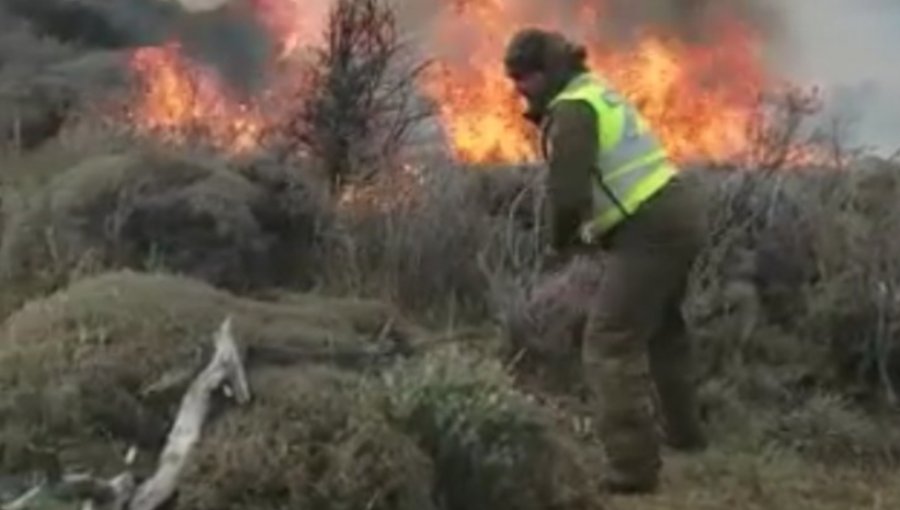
121;0;800;167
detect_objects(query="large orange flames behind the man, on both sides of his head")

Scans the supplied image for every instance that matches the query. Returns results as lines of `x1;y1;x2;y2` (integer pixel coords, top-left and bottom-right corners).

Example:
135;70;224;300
424;0;765;162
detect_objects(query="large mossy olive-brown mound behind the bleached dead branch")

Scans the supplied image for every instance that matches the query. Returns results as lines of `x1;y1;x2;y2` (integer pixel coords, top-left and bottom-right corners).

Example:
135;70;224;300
0;272;405;472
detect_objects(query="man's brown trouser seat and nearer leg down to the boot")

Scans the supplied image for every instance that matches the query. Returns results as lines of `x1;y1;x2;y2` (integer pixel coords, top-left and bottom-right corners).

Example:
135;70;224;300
583;173;705;491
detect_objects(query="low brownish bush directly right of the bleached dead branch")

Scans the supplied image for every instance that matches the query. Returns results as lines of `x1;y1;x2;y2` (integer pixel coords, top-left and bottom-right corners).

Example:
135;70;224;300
178;367;438;510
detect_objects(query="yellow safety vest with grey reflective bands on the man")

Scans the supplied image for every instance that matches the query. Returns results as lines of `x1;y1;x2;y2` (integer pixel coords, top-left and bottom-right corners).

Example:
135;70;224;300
544;73;677;243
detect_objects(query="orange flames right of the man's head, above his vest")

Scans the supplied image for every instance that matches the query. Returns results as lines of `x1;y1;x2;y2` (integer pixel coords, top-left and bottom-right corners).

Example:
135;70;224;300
592;21;766;161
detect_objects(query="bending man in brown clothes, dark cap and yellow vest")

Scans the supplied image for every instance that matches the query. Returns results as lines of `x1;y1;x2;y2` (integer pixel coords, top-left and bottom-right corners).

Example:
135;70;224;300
505;28;705;493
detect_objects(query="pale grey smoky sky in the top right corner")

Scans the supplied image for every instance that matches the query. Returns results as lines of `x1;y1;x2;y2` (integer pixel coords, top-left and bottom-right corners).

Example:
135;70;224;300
773;0;900;155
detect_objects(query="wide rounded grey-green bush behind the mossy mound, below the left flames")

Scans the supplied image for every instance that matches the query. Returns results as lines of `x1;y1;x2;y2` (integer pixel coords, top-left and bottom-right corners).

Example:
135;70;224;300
0;144;325;310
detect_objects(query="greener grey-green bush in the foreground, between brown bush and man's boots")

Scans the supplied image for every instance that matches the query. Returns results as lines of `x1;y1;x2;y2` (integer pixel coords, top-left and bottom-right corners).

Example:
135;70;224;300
385;349;599;510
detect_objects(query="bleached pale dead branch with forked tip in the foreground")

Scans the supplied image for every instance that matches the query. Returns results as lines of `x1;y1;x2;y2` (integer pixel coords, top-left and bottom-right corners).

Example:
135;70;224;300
128;317;250;510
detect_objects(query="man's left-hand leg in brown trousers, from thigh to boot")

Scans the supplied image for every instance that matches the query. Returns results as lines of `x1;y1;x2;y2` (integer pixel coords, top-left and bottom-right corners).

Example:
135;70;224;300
583;250;665;492
